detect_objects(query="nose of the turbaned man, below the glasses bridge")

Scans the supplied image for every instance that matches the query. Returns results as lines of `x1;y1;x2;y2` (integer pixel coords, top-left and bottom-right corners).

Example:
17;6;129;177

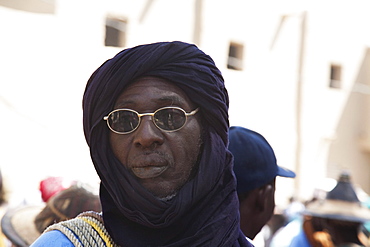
134;116;164;148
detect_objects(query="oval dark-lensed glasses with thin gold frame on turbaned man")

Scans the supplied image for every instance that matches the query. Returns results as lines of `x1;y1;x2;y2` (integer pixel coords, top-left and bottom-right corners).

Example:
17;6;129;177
103;106;199;134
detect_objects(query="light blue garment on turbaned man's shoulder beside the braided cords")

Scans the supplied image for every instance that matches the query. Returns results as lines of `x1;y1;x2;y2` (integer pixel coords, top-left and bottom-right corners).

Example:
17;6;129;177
30;230;74;247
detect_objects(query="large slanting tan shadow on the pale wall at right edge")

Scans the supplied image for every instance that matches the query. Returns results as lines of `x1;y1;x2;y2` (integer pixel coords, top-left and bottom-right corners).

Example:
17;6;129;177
327;46;370;193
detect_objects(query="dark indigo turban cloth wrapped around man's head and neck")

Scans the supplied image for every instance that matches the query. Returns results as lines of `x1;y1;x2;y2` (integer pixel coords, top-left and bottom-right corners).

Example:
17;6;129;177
83;42;249;247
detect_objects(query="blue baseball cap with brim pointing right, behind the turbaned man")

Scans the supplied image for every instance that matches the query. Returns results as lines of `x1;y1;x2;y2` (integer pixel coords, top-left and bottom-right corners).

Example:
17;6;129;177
229;126;296;194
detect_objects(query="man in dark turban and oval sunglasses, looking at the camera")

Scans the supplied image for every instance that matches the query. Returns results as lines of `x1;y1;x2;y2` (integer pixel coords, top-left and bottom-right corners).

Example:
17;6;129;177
33;42;251;247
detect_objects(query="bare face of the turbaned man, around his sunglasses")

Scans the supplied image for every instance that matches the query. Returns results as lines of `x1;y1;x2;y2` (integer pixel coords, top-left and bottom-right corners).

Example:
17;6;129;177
110;77;201;198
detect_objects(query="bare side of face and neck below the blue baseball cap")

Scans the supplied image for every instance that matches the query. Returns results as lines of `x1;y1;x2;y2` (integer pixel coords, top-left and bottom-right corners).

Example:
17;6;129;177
239;179;275;239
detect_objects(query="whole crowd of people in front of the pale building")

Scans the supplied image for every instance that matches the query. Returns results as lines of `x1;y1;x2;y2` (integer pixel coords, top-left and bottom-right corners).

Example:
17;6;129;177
1;41;370;247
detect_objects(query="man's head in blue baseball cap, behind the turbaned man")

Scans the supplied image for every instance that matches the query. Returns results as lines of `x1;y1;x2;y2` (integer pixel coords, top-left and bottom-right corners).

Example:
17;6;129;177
229;126;295;242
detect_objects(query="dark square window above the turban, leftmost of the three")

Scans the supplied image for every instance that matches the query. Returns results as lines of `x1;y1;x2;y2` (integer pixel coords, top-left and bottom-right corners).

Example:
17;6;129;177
105;18;127;47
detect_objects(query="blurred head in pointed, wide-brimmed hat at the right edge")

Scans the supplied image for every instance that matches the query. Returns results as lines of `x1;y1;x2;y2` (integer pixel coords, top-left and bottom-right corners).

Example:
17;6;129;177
304;172;370;246
